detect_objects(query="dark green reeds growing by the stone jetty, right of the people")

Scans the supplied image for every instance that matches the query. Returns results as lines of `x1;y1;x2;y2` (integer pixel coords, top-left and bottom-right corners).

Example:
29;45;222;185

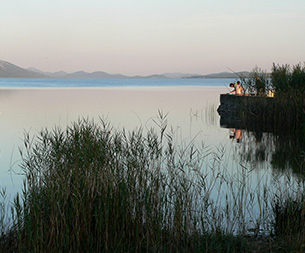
238;64;305;134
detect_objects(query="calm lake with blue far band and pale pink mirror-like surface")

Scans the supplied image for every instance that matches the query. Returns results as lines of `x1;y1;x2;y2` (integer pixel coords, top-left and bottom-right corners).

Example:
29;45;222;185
0;79;304;233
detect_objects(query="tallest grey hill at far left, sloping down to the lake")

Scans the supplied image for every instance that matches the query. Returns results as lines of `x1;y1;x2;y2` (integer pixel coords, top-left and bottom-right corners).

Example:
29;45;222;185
0;60;46;78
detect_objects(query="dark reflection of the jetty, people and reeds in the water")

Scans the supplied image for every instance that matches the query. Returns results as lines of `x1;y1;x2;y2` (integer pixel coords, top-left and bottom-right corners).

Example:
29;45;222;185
220;114;305;178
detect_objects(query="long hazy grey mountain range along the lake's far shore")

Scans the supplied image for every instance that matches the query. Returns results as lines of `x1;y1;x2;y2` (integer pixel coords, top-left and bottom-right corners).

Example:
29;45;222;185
0;60;249;79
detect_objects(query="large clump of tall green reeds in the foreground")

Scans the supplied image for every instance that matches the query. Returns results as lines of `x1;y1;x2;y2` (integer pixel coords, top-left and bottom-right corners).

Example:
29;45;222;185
0;117;303;252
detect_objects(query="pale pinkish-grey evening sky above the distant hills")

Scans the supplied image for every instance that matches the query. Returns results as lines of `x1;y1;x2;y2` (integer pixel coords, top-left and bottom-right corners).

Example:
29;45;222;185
0;0;305;75
